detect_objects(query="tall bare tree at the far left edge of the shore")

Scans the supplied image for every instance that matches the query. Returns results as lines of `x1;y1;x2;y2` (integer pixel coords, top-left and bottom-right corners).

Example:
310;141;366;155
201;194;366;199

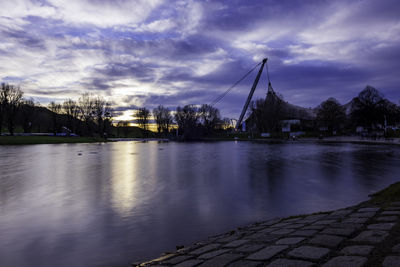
0;83;23;135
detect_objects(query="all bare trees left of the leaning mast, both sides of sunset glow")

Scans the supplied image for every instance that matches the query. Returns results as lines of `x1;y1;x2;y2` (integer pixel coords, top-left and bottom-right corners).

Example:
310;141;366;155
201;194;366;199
0;83;231;139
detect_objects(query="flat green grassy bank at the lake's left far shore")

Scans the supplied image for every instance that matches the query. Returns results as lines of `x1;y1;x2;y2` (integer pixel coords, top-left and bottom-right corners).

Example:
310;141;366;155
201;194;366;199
0;136;109;145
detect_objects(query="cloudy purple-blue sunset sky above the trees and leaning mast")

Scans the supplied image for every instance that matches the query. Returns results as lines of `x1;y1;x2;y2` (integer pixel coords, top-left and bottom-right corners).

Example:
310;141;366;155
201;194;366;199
0;0;400;119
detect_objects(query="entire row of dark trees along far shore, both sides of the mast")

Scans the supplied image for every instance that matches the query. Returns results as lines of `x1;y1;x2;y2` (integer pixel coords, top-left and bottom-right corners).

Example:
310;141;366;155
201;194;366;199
0;83;394;140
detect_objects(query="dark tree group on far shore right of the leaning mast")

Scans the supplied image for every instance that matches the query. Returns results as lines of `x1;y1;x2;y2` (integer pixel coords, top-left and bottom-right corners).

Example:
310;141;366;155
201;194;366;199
248;86;400;135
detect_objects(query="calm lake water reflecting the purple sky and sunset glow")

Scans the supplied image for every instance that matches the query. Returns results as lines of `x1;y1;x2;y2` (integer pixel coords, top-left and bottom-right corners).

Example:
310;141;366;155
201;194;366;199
0;142;400;266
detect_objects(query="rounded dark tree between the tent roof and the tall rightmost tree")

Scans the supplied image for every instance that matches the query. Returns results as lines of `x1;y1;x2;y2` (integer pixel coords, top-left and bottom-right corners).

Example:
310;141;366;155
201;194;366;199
317;98;346;132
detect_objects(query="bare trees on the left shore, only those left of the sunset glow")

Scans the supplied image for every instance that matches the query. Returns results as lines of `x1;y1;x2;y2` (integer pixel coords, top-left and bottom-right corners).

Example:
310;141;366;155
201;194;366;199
0;83;112;137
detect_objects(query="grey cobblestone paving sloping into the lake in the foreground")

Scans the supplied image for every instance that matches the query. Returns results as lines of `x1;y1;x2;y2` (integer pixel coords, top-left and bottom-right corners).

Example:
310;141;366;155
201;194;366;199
133;202;400;267
